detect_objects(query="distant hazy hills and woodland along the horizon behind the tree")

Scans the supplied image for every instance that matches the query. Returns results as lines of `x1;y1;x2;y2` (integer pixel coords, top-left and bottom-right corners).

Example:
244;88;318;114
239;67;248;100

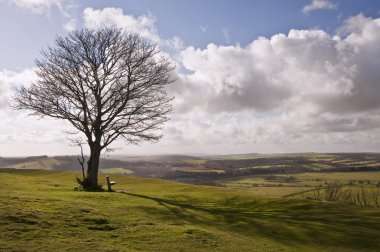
0;153;380;184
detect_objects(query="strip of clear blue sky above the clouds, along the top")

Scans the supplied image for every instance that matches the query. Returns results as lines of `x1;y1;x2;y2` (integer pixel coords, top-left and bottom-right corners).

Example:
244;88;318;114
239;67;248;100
0;0;380;68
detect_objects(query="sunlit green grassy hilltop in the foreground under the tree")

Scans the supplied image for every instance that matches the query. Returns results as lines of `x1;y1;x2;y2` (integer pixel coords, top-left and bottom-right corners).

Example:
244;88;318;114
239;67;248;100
0;169;380;251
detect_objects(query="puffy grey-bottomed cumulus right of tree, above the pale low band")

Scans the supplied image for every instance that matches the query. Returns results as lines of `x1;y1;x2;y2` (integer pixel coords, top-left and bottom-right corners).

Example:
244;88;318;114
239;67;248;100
174;16;380;114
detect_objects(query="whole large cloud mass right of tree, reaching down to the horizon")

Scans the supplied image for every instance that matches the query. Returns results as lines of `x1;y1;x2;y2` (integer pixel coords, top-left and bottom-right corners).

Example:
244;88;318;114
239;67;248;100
165;15;380;151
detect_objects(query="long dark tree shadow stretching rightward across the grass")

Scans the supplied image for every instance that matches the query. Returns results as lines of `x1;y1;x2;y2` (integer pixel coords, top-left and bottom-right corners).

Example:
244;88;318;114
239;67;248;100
120;192;380;250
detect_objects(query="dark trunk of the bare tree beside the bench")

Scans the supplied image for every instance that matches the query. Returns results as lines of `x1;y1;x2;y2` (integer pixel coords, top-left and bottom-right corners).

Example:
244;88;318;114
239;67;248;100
84;142;101;190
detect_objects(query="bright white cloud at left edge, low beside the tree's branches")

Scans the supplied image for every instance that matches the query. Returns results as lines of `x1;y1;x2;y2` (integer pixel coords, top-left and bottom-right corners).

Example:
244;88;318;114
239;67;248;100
0;68;73;155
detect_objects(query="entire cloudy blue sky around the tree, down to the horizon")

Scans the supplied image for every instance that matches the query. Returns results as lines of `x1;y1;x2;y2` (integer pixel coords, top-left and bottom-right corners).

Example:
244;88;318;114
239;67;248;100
0;0;380;156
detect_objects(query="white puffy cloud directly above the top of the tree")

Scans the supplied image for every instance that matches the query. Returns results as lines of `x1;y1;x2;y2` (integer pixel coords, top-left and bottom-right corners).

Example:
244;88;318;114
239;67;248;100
83;8;160;42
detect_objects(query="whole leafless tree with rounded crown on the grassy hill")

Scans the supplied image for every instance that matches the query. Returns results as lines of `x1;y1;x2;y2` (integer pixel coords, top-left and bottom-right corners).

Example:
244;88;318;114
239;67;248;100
14;28;174;190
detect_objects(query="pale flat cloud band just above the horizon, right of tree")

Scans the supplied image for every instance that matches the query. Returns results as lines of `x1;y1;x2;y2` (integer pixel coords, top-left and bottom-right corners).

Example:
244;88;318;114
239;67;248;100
138;110;380;154
